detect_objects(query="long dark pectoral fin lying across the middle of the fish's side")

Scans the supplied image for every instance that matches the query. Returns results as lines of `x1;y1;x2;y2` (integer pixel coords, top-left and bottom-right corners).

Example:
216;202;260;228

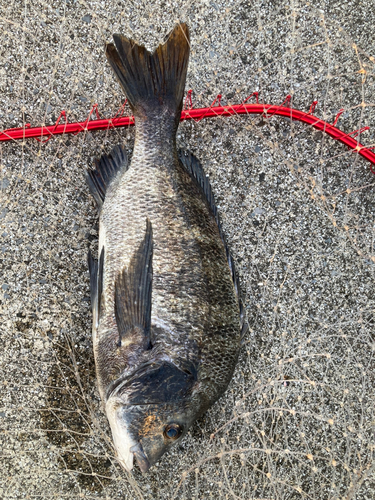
115;219;153;344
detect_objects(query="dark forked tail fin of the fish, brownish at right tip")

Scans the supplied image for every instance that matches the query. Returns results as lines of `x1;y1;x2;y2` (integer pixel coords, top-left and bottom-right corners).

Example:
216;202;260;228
106;23;190;120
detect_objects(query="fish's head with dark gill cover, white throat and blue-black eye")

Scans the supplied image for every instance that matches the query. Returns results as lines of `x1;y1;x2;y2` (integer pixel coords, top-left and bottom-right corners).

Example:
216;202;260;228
106;361;201;472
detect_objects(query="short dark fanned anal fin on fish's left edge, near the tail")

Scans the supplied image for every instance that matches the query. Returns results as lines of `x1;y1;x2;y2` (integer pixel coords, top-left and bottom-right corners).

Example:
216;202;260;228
86;145;128;210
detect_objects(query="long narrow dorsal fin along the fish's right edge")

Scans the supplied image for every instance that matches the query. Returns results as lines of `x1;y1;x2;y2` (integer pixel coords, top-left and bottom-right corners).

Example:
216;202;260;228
178;150;248;336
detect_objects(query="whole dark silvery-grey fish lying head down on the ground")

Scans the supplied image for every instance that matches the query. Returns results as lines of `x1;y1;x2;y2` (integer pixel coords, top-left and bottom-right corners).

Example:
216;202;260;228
87;23;246;473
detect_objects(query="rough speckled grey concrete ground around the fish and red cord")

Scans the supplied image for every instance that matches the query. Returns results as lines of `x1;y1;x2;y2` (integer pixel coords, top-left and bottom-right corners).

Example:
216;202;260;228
0;0;375;500
